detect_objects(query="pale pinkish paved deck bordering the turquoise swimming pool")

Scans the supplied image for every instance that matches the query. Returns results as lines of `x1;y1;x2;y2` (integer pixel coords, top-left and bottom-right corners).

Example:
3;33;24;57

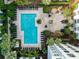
16;9;42;48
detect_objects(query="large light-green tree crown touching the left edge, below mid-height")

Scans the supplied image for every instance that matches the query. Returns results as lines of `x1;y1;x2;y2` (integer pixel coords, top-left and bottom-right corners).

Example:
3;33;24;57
0;33;10;56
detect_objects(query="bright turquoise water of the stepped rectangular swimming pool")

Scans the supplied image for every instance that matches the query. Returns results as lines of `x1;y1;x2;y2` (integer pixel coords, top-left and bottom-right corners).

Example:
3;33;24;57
21;14;37;44
